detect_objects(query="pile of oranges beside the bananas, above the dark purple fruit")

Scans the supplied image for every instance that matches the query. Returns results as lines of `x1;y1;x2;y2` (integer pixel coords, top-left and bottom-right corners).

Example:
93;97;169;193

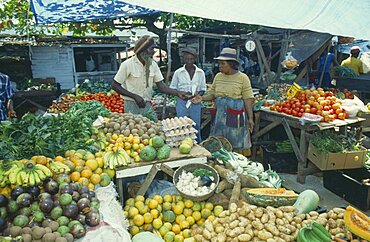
62;150;115;190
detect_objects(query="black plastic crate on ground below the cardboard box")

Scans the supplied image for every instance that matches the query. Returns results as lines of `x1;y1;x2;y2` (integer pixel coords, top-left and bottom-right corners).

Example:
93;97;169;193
323;168;370;211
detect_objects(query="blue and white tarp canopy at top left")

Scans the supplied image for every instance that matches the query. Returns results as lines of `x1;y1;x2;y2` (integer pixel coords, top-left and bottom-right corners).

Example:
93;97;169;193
31;0;159;24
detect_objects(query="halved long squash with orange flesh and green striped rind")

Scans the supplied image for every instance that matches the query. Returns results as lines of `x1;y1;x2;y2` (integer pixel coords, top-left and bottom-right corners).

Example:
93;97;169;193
246;188;298;207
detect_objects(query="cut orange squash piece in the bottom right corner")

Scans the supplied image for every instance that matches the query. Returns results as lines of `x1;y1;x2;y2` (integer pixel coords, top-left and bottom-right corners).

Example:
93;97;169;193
344;206;370;241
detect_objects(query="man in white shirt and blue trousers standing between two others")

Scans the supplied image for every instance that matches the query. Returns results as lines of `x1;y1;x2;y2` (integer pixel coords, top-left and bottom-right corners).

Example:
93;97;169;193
170;48;206;143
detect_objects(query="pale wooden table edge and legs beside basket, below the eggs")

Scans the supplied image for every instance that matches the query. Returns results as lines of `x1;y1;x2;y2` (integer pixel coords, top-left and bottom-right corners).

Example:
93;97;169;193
116;157;207;204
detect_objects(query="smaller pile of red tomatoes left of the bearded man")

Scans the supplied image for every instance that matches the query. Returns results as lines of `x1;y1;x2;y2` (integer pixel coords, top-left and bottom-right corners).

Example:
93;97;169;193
79;92;125;113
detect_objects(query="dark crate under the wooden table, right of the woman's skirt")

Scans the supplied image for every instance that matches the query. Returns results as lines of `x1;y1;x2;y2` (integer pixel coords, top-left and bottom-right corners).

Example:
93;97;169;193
262;145;298;173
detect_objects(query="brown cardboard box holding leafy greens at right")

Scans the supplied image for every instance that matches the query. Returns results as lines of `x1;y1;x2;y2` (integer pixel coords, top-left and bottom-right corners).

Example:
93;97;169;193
307;143;367;171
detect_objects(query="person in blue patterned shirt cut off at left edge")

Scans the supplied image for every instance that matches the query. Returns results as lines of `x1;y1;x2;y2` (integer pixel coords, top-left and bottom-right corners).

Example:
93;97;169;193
0;72;17;121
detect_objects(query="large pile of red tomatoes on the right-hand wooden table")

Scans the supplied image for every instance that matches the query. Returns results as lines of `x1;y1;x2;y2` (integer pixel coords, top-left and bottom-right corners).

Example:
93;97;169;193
265;88;348;122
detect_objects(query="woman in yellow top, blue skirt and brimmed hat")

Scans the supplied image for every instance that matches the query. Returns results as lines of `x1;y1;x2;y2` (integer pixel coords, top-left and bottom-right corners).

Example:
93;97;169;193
192;48;254;150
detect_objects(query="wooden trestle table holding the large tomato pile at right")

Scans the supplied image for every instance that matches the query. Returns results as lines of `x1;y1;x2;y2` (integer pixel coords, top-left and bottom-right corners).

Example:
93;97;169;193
252;109;365;183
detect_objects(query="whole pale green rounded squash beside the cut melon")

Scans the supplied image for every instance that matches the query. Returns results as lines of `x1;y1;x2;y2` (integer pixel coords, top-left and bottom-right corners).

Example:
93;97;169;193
293;190;320;214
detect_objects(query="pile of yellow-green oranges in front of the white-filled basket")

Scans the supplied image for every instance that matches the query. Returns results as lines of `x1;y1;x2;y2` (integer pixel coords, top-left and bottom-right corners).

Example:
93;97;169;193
124;195;223;242
